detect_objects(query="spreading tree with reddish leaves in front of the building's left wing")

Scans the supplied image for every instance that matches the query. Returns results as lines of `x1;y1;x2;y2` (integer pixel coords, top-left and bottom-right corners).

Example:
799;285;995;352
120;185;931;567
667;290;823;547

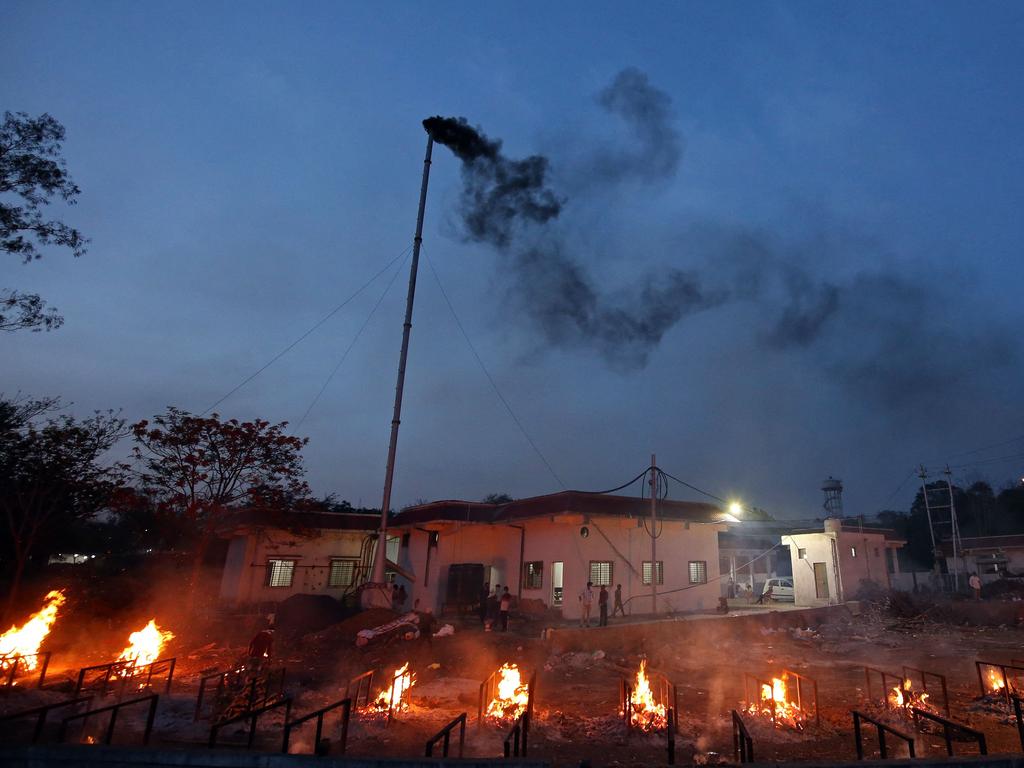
132;407;309;600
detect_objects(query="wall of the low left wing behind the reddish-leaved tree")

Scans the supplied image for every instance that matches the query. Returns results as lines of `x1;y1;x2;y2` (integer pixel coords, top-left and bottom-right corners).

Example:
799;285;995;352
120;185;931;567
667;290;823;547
220;529;369;603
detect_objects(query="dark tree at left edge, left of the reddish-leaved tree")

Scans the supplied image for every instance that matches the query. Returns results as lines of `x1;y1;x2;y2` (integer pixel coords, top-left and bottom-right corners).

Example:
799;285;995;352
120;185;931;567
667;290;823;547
0;398;126;614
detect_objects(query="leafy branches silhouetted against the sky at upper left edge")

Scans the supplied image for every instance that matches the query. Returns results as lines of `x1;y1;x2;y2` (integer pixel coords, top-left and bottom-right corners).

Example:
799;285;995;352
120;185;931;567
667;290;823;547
0;112;88;331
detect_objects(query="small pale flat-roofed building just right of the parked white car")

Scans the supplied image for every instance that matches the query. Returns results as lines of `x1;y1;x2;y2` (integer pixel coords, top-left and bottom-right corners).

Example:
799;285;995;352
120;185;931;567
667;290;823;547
781;517;906;606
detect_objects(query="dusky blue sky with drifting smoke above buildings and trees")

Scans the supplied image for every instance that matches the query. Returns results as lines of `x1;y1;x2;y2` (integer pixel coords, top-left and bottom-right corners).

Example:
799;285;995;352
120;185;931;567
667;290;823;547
0;0;1024;517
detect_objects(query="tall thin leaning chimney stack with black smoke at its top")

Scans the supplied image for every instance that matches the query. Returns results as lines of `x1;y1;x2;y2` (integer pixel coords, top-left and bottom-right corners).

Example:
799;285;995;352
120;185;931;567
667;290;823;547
362;133;434;606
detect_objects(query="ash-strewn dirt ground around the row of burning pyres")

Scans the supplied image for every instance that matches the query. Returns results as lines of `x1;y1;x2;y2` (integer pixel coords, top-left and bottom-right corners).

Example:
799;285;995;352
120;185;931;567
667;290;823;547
0;605;1024;767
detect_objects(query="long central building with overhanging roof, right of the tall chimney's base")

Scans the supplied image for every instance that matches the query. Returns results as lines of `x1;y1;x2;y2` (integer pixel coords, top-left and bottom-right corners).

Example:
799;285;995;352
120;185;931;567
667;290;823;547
391;492;726;620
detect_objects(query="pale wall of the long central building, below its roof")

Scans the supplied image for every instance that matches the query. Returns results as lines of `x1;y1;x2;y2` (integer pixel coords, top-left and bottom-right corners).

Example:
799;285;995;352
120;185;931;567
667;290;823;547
402;514;724;618
